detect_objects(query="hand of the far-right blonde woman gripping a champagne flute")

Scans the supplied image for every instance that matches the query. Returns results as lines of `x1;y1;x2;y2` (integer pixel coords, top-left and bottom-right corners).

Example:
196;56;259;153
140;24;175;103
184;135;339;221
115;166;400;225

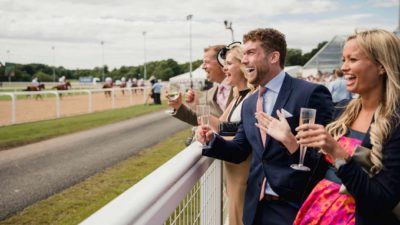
296;124;349;160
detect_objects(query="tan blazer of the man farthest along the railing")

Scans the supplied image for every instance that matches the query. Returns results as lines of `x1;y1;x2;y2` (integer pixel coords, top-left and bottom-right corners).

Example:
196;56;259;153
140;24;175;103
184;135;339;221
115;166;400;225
173;86;233;126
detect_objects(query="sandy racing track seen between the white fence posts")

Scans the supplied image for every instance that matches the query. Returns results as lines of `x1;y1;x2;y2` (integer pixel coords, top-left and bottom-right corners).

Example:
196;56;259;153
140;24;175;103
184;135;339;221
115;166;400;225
0;91;152;126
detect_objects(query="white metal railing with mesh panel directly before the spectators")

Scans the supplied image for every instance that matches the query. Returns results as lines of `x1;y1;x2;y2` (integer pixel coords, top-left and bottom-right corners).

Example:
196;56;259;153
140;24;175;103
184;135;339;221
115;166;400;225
81;142;227;225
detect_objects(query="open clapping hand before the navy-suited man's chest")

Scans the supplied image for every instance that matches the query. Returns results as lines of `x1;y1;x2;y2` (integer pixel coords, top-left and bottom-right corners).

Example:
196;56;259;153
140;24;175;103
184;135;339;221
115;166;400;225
255;110;298;153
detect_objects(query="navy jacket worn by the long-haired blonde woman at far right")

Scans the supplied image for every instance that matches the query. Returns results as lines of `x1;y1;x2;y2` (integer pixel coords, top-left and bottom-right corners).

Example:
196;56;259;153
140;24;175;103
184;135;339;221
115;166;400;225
337;108;400;225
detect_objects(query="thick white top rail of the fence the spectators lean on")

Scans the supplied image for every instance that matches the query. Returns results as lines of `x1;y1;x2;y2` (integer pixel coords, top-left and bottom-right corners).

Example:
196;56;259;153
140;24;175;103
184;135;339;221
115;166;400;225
81;142;217;225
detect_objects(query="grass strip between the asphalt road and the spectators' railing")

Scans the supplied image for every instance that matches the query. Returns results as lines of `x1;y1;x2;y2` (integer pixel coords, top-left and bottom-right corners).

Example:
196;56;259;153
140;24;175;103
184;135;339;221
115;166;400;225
0;129;190;225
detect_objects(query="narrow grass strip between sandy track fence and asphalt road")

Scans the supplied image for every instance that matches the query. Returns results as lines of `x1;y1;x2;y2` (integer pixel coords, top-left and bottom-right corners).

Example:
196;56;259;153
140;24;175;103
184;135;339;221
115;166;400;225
0;104;167;150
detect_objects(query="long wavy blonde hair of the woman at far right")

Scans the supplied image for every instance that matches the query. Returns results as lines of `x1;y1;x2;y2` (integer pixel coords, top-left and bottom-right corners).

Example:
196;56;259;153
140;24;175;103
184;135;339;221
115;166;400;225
327;29;400;174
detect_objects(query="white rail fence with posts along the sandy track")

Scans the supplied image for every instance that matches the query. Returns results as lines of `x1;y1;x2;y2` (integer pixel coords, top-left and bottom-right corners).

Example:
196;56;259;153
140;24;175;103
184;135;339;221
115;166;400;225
0;87;151;125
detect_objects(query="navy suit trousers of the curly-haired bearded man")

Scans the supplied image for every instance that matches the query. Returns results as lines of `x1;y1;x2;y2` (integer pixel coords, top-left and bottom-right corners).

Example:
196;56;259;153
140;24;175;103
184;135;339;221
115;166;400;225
253;200;299;225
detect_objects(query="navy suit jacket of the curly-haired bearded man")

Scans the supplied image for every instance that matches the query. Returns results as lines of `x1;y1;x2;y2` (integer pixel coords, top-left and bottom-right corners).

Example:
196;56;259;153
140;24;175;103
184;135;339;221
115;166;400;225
203;74;333;225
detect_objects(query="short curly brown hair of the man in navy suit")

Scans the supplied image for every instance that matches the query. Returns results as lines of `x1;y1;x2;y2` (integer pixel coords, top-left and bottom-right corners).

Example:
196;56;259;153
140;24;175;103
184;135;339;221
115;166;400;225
243;28;286;68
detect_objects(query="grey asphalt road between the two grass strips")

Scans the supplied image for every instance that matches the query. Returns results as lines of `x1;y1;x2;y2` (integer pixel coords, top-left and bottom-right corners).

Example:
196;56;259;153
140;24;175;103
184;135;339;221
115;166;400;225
0;111;189;220
